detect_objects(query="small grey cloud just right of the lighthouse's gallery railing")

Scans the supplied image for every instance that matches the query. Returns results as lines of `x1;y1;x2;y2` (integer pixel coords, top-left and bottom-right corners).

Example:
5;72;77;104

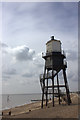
66;50;78;61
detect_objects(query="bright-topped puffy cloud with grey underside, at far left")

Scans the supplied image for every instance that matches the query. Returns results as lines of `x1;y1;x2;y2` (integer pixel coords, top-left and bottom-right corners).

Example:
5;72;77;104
2;43;35;61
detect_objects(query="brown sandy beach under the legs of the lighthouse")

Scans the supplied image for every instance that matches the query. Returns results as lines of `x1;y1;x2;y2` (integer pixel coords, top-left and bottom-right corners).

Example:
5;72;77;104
3;93;79;118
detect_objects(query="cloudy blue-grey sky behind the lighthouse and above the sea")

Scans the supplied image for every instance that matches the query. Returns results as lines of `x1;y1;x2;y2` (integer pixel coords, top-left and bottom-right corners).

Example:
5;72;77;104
0;2;78;94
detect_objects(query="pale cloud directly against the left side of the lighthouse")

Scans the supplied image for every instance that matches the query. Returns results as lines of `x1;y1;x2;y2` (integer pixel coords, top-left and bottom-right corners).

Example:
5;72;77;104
22;53;44;78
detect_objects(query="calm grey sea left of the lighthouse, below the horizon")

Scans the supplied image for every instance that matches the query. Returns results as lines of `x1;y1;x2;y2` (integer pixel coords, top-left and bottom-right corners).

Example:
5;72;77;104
0;93;41;110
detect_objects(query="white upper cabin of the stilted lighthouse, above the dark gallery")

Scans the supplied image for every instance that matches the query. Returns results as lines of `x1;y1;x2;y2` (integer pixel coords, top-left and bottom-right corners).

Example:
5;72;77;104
46;39;61;53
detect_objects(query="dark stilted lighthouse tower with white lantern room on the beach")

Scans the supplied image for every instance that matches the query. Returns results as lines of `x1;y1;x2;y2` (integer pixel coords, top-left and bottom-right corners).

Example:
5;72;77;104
40;36;71;108
